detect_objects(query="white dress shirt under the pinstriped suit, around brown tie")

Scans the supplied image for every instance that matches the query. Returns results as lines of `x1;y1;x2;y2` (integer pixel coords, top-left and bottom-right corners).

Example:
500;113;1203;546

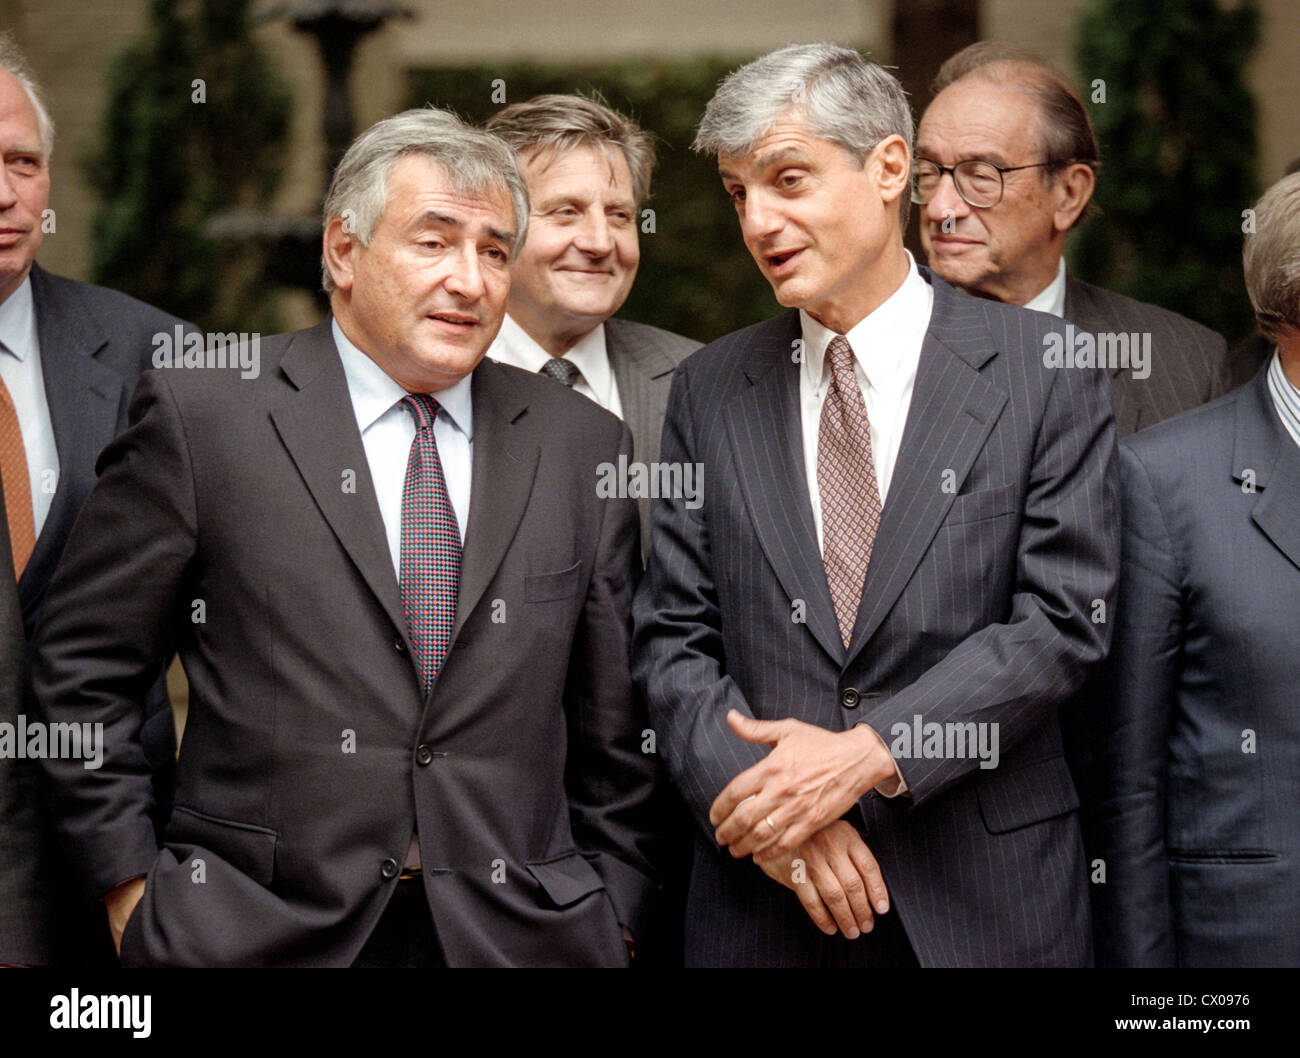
800;253;935;551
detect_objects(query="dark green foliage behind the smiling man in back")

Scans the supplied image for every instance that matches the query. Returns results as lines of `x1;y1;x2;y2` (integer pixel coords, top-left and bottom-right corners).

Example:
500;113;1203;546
407;58;780;342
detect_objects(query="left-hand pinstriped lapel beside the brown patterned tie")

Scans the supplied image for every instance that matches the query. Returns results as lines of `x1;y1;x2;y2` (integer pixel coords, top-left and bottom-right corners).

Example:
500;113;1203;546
725;312;844;664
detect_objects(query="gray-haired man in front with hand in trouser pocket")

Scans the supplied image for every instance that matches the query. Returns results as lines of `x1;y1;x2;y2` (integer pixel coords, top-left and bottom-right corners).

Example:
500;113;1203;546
35;109;653;966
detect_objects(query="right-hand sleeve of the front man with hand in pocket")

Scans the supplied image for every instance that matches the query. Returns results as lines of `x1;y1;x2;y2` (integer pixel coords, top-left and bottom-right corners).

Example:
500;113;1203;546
564;426;655;935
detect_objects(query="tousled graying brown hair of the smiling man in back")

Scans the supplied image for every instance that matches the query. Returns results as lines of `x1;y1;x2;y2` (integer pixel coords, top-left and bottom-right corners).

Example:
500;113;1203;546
485;95;655;205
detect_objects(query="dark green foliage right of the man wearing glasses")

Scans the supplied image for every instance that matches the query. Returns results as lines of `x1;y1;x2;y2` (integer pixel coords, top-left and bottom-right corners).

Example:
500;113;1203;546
1074;0;1260;346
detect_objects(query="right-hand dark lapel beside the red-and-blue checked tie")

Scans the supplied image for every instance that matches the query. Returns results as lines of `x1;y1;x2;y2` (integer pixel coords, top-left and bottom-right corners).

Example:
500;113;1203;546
451;359;540;642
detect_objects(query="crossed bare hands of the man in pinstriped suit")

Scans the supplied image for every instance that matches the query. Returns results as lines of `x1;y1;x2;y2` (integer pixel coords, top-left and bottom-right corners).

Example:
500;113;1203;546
709;710;896;940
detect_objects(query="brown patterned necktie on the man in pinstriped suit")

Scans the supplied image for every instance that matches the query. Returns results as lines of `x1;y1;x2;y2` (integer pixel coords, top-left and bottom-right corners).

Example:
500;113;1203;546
816;334;881;649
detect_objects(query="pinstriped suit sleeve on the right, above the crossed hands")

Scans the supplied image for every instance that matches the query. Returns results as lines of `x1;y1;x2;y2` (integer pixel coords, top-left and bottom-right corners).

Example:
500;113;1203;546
874;340;1119;806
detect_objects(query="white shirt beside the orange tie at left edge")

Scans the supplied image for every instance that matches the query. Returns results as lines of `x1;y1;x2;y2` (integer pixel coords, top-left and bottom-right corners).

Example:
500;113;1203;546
0;274;59;537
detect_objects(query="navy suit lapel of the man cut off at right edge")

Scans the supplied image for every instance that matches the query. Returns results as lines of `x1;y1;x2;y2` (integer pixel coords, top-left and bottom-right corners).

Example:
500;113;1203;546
1232;367;1300;577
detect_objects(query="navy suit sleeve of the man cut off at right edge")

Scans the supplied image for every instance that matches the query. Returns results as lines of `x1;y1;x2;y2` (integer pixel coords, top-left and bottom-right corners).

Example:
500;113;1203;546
1084;447;1184;966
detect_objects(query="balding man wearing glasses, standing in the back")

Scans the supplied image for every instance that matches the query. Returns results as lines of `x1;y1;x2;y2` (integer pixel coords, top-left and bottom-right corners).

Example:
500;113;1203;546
914;40;1227;437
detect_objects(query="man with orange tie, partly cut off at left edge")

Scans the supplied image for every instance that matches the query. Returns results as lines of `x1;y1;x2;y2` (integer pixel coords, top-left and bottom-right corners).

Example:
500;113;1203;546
0;36;192;963
